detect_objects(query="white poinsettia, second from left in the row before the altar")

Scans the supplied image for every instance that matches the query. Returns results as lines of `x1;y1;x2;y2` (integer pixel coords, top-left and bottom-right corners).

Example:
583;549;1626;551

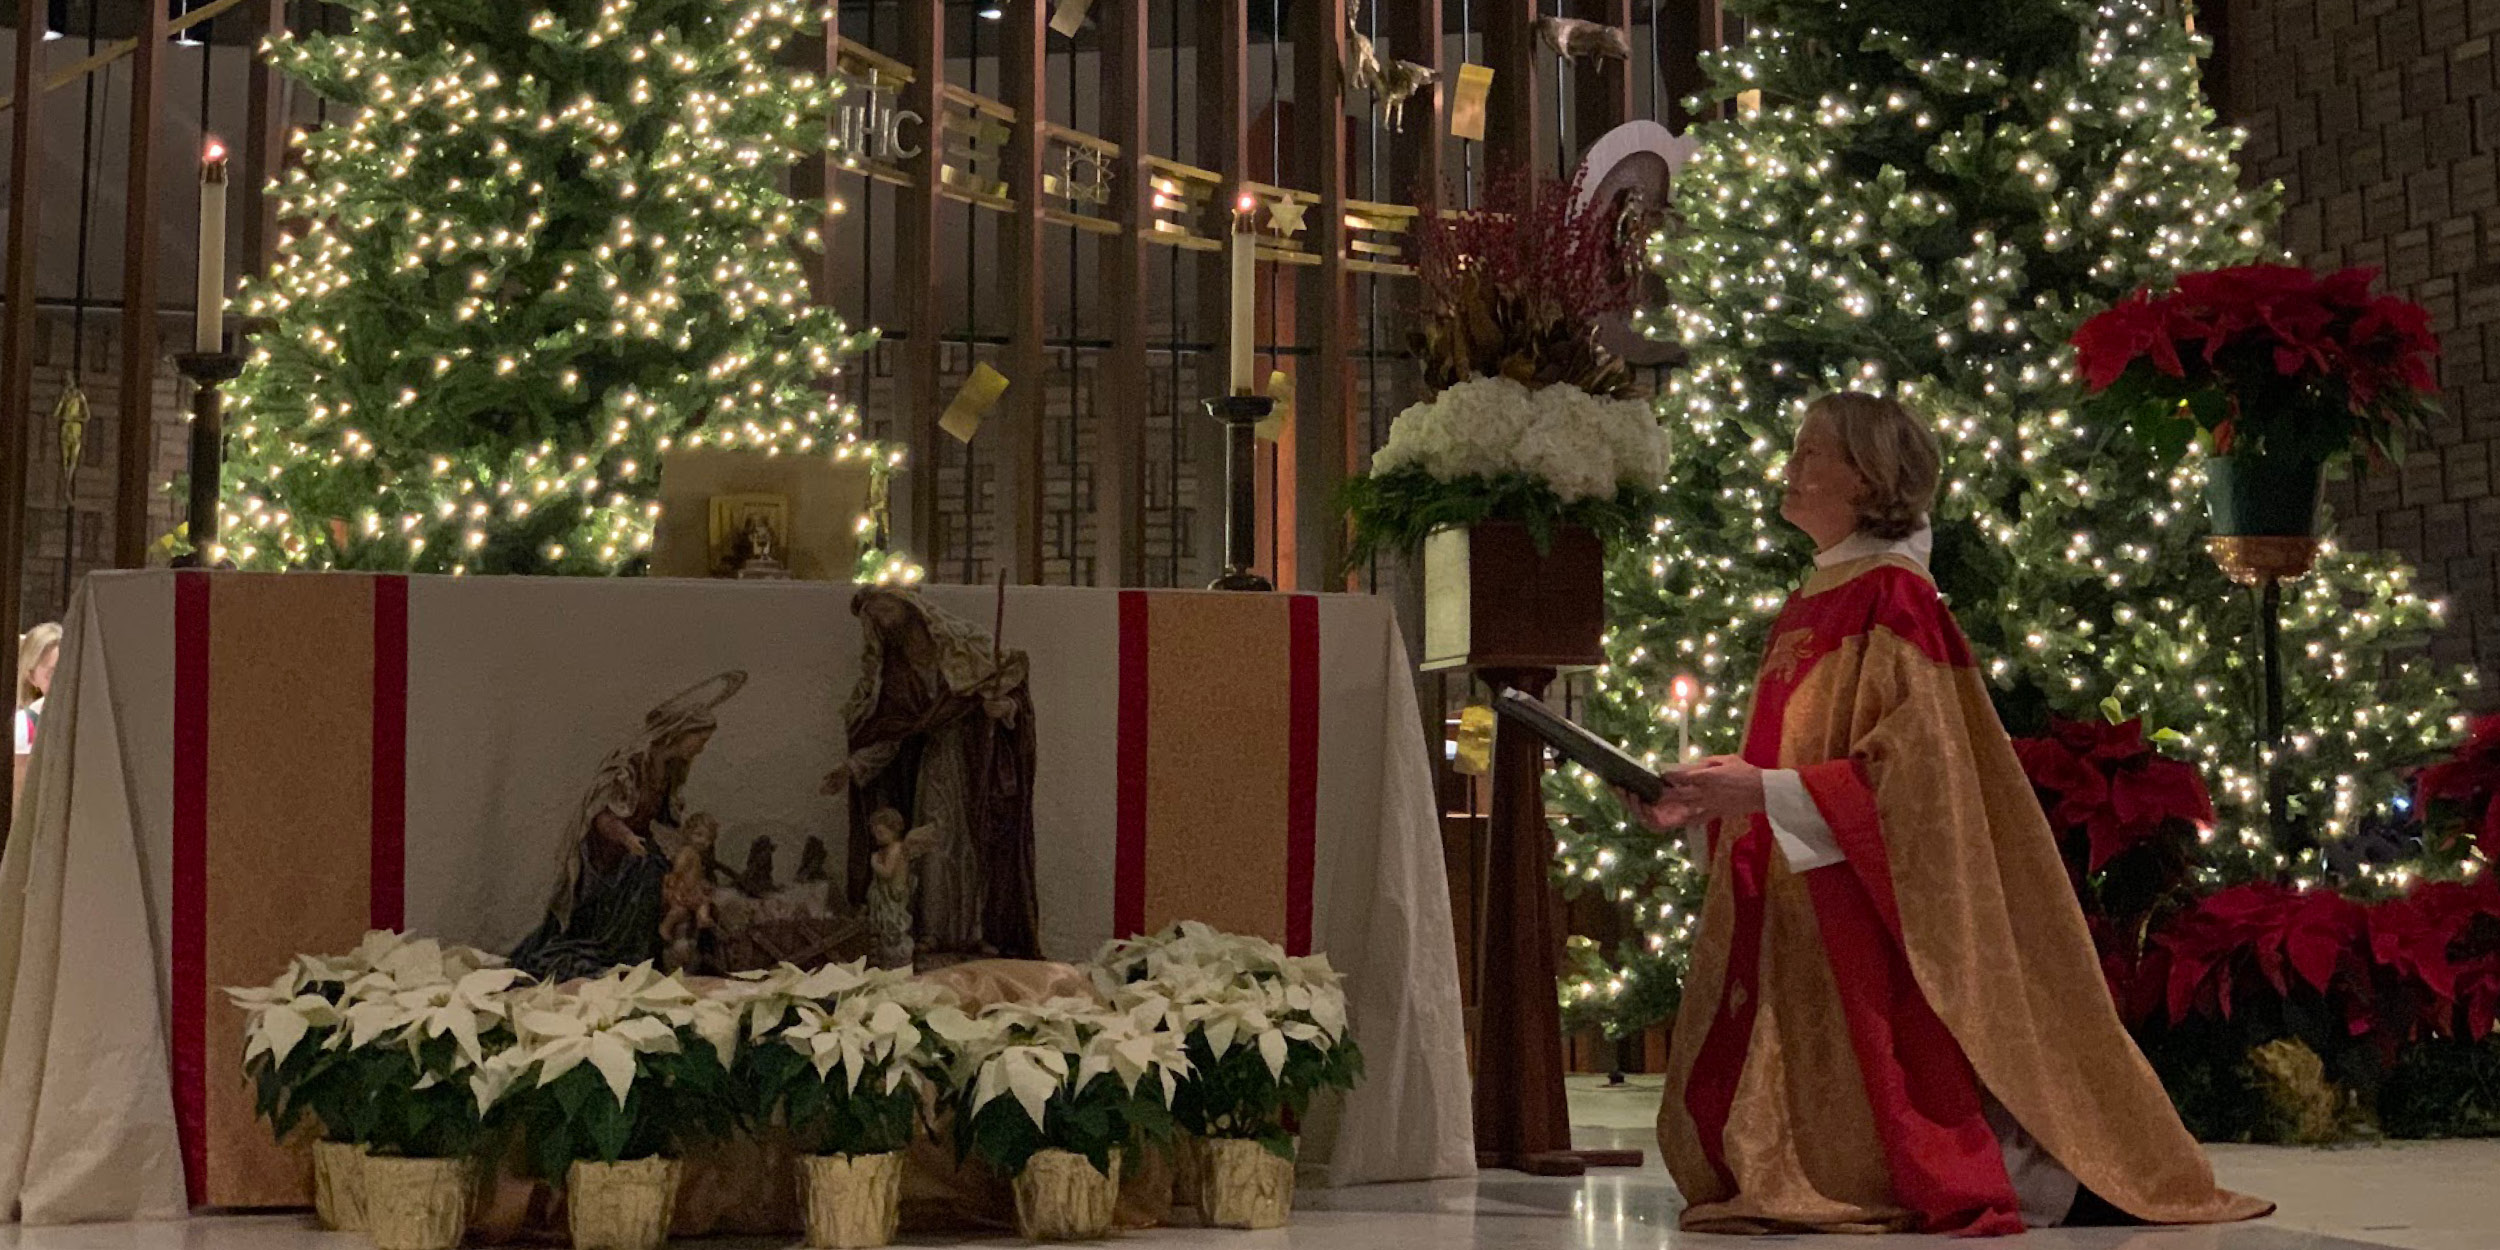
497;963;745;1183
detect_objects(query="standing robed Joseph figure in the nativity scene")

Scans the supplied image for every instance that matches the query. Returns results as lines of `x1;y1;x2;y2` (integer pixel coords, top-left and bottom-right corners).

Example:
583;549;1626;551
825;585;1043;965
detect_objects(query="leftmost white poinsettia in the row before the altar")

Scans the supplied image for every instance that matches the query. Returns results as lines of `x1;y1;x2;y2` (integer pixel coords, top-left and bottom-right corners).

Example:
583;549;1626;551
228;930;525;1158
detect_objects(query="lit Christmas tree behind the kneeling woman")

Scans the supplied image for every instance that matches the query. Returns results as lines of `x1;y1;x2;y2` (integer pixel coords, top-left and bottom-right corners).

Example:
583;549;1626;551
1553;0;2475;1030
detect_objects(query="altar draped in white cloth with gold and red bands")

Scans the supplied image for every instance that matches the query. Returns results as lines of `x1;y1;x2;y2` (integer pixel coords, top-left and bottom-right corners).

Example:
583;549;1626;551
0;573;1475;1223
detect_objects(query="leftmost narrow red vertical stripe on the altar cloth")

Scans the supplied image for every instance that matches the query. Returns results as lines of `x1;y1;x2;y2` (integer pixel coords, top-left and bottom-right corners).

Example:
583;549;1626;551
168;573;210;1205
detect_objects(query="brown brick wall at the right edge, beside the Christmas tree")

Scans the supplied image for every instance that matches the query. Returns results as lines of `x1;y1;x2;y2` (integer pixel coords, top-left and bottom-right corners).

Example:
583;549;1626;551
2210;0;2500;675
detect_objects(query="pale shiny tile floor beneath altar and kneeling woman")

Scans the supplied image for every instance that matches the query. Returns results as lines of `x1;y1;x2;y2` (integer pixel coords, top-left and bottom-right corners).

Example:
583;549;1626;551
0;1080;2500;1250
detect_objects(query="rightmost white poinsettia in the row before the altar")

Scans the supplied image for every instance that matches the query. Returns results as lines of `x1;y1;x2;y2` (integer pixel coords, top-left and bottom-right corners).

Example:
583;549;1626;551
1095;923;1363;1158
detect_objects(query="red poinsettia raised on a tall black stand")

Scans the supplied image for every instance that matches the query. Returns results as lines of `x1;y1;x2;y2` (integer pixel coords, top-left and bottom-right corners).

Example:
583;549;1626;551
2075;265;2440;463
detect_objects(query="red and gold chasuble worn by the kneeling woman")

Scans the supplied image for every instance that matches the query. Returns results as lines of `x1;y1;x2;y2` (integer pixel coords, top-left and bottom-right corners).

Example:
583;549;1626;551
1658;555;2270;1235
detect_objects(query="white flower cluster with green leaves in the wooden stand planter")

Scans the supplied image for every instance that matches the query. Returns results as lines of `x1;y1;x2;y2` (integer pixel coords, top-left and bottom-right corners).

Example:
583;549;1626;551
1345;378;1668;558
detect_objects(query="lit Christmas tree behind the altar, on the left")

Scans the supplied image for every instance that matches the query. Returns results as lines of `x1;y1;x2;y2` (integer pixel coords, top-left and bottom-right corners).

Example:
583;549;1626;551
220;0;903;575
